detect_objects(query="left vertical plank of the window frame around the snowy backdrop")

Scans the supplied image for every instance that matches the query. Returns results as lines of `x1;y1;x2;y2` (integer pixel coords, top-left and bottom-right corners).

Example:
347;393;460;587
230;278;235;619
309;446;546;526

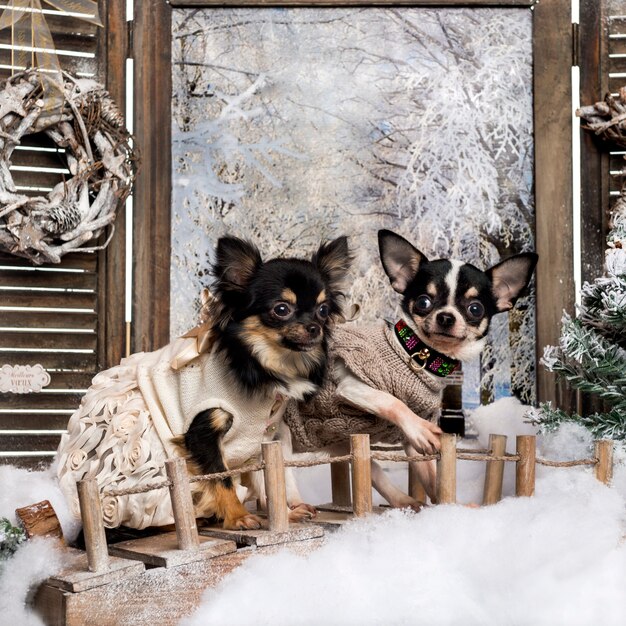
132;0;172;352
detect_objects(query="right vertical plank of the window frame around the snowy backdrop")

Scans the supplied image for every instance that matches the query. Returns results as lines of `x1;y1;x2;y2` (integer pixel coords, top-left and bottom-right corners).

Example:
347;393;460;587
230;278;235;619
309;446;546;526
533;0;575;410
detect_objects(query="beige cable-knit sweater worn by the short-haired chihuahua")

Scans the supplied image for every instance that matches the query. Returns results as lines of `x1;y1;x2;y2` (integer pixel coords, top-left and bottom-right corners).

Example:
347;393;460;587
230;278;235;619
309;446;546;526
284;323;446;452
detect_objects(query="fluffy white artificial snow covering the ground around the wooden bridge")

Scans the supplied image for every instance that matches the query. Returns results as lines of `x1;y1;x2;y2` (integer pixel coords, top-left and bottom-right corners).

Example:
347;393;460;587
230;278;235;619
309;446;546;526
0;399;626;626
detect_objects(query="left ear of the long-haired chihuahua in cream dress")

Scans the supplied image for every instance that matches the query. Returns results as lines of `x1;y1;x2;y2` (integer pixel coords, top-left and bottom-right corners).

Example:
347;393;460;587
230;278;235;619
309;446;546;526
213;237;263;291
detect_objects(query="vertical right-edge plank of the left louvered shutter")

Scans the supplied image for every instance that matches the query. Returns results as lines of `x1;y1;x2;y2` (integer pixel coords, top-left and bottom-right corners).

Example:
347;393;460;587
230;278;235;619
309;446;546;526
97;0;127;368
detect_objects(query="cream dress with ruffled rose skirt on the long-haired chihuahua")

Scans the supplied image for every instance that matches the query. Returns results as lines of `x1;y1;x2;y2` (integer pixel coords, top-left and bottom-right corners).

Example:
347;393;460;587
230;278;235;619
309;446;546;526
57;338;282;528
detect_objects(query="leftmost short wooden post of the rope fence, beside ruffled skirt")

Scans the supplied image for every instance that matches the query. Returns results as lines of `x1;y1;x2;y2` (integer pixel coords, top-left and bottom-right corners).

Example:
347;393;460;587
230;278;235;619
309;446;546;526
76;478;109;572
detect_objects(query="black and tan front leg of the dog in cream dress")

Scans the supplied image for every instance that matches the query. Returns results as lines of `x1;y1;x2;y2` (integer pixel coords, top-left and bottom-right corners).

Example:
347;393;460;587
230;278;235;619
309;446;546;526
184;408;261;530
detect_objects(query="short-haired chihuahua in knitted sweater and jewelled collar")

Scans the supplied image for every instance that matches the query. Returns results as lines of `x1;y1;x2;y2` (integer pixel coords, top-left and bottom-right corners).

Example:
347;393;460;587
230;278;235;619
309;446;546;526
286;230;538;509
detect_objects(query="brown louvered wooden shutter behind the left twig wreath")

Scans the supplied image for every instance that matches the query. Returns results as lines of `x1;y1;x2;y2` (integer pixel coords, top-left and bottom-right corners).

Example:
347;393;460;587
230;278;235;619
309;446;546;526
0;0;128;467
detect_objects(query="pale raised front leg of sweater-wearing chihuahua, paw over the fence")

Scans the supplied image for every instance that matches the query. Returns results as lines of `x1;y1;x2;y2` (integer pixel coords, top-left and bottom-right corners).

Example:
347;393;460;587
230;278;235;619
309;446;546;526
336;369;442;454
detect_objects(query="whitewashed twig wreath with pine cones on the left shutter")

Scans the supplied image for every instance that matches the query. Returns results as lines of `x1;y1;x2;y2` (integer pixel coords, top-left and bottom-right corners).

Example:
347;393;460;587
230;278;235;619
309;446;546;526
0;69;138;265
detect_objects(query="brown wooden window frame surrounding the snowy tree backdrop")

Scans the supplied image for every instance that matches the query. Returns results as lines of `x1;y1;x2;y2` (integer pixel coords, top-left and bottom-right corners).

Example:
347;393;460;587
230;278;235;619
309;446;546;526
132;0;575;408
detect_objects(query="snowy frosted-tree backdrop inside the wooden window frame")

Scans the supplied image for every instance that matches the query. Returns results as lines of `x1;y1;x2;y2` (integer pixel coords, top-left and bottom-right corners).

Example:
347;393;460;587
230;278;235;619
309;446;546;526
171;8;534;403
